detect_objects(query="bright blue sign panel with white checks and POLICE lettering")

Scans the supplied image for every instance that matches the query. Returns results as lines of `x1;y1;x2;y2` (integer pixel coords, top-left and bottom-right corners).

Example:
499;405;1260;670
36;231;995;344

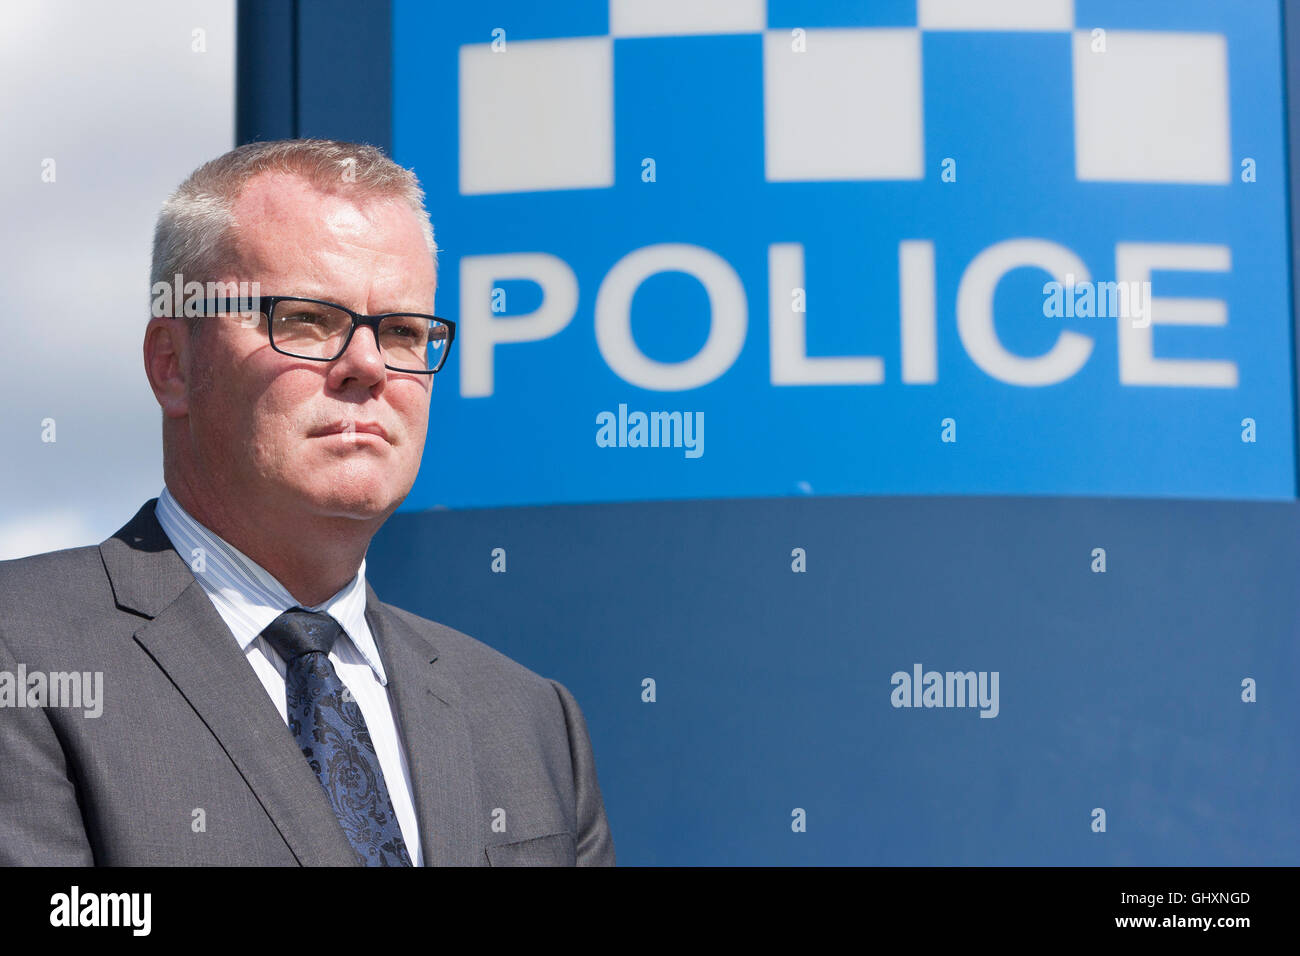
393;0;1296;510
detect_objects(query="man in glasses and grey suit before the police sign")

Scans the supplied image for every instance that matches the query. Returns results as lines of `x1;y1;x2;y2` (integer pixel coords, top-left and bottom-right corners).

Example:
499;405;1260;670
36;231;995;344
0;140;614;866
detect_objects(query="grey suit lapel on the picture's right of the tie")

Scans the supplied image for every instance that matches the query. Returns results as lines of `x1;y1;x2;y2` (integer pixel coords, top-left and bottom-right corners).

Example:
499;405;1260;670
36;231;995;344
365;590;486;866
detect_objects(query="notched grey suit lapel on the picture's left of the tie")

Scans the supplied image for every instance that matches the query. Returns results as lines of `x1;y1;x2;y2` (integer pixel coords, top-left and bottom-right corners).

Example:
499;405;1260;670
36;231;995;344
100;499;358;866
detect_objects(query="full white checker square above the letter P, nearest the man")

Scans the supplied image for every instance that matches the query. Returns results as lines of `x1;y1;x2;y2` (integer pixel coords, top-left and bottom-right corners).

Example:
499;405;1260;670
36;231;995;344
460;36;614;195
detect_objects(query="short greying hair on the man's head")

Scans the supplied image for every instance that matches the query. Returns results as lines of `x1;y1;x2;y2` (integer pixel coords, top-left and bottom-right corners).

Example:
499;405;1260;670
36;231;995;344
150;139;438;317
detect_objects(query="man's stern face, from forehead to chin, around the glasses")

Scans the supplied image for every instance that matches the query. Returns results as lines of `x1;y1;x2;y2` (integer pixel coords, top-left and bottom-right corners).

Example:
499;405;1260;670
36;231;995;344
180;173;436;520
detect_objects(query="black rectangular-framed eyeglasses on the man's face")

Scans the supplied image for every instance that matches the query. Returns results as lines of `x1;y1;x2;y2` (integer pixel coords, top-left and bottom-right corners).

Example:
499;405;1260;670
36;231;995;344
187;295;456;375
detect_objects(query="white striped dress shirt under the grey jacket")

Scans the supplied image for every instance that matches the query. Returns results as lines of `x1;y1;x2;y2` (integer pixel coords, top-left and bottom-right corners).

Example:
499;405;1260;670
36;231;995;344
155;486;424;866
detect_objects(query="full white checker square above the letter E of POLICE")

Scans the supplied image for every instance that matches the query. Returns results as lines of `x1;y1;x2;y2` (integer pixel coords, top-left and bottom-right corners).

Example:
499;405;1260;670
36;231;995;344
1074;30;1232;183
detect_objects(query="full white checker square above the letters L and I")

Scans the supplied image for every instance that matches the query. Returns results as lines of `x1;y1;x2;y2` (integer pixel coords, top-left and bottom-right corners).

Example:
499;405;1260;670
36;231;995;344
763;29;926;182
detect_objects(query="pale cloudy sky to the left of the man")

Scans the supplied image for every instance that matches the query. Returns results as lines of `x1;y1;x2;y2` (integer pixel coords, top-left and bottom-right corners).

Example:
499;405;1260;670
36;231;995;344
0;0;235;559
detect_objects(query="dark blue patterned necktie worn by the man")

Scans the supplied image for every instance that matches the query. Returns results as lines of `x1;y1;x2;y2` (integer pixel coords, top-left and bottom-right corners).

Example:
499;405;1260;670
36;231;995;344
261;607;411;866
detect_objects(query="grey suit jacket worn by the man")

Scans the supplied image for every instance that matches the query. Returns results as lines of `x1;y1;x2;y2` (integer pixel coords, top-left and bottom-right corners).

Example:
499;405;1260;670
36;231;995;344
0;498;614;866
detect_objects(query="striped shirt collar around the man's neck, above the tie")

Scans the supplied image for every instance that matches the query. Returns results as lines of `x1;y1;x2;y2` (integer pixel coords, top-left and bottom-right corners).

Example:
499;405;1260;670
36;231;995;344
155;485;387;685
